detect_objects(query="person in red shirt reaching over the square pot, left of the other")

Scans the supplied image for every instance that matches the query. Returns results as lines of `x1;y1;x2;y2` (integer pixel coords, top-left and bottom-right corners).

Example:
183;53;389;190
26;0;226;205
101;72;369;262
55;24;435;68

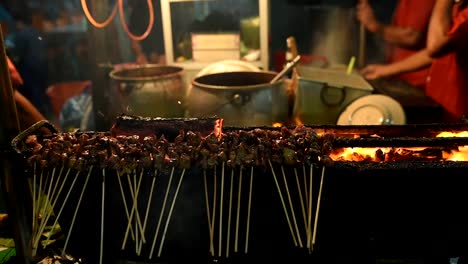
357;0;435;89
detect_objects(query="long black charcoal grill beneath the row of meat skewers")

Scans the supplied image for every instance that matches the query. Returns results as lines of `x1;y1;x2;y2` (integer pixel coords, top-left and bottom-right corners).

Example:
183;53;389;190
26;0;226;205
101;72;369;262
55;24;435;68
7;118;468;263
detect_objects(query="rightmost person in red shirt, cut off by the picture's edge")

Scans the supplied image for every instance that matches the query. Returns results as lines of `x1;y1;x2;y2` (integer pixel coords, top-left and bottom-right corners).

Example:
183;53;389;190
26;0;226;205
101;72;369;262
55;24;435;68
426;0;468;122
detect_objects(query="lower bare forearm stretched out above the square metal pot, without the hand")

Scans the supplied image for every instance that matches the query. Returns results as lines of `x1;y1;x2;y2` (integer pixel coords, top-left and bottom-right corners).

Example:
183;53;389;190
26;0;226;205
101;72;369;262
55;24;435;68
387;49;432;76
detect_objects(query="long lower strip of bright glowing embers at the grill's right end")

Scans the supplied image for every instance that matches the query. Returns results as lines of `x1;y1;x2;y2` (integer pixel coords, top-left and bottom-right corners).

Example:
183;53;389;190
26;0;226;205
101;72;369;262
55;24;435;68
330;146;468;162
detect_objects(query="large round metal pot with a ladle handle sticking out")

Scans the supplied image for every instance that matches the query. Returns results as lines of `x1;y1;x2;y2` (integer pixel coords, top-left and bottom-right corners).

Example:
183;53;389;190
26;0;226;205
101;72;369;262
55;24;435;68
187;71;288;126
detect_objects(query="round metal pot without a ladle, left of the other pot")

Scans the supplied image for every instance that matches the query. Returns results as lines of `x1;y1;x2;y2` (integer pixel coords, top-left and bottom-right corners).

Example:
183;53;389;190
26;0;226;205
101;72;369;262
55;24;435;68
110;64;187;117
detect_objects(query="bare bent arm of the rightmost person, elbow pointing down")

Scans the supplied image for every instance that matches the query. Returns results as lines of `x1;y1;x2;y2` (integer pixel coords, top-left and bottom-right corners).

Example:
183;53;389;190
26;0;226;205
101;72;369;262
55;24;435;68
427;0;453;57
